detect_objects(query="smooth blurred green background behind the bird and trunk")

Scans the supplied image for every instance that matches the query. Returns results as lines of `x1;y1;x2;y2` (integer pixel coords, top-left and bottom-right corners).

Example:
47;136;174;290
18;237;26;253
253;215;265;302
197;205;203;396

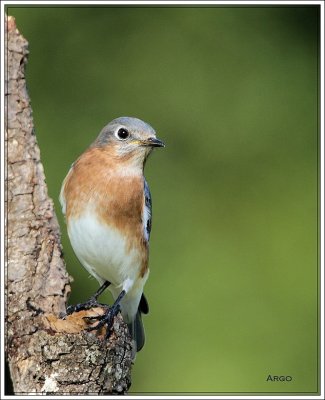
7;6;319;394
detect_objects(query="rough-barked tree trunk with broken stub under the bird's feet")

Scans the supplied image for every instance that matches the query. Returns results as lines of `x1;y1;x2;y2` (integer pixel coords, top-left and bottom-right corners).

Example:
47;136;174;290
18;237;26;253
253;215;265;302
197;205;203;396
5;17;132;395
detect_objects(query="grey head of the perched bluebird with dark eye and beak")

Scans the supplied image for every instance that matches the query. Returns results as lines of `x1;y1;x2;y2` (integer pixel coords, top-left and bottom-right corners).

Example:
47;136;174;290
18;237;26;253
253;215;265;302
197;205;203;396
94;117;165;165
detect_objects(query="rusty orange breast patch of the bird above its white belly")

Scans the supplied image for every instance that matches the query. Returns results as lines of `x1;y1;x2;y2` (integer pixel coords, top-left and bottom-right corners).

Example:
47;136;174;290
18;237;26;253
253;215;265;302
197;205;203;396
64;148;148;276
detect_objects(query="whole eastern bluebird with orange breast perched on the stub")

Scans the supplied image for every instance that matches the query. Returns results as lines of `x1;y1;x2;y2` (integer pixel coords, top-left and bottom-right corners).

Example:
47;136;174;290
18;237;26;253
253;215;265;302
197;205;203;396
60;117;164;351
